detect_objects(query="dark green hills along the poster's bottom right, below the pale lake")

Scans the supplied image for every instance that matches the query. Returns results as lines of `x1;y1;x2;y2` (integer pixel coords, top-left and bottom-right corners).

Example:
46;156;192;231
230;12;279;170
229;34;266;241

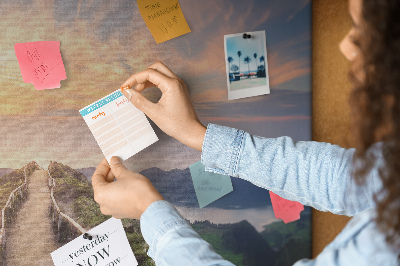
191;216;311;266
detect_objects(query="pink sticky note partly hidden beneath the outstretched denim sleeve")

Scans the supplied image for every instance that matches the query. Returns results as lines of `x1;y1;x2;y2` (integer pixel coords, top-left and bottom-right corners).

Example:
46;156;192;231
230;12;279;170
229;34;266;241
269;191;304;224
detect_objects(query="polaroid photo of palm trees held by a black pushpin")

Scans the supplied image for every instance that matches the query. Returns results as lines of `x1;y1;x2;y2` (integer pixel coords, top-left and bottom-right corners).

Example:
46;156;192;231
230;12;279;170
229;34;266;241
224;31;270;100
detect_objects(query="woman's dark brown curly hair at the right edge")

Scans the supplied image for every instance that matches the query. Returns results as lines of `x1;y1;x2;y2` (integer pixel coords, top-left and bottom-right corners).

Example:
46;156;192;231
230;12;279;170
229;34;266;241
350;0;400;255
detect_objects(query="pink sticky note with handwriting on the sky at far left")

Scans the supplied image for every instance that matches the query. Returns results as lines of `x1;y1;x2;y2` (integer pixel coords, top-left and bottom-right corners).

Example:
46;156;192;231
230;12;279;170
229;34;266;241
14;41;67;90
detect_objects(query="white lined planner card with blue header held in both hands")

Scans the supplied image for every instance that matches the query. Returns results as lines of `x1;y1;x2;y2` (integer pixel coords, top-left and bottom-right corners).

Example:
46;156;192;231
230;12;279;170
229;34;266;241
79;90;158;161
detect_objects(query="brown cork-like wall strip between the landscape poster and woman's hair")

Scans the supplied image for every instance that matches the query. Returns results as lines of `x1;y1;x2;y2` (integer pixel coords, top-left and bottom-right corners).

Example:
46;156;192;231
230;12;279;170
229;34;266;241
312;0;354;257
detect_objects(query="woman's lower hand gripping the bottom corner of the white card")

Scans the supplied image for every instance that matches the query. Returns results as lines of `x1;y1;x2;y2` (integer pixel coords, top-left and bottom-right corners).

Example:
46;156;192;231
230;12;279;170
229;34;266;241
92;157;164;219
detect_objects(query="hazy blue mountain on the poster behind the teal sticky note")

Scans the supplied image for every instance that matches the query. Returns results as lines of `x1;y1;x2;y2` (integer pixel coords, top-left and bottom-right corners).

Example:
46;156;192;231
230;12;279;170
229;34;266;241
140;167;271;209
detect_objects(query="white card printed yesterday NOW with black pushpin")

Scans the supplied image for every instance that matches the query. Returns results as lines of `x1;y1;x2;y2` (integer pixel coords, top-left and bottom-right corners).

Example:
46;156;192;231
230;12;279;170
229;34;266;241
51;218;138;266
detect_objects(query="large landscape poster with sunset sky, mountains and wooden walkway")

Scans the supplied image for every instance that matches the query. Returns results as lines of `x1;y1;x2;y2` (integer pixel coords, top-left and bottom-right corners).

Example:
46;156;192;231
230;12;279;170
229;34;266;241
0;0;311;266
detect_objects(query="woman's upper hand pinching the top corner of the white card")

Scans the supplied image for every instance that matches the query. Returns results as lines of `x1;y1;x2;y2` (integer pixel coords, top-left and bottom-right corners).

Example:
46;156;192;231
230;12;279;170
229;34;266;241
121;62;206;151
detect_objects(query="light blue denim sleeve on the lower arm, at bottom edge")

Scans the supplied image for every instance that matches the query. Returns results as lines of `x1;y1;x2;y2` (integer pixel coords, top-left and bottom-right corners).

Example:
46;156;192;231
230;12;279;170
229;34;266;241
140;200;233;266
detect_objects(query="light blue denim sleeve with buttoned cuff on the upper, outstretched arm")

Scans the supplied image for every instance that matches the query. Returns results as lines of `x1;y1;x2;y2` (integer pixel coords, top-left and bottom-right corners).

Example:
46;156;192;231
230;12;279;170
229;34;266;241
202;124;381;216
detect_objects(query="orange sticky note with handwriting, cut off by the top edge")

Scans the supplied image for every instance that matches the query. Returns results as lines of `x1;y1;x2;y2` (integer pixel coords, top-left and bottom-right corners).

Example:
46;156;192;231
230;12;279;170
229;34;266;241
137;0;190;43
